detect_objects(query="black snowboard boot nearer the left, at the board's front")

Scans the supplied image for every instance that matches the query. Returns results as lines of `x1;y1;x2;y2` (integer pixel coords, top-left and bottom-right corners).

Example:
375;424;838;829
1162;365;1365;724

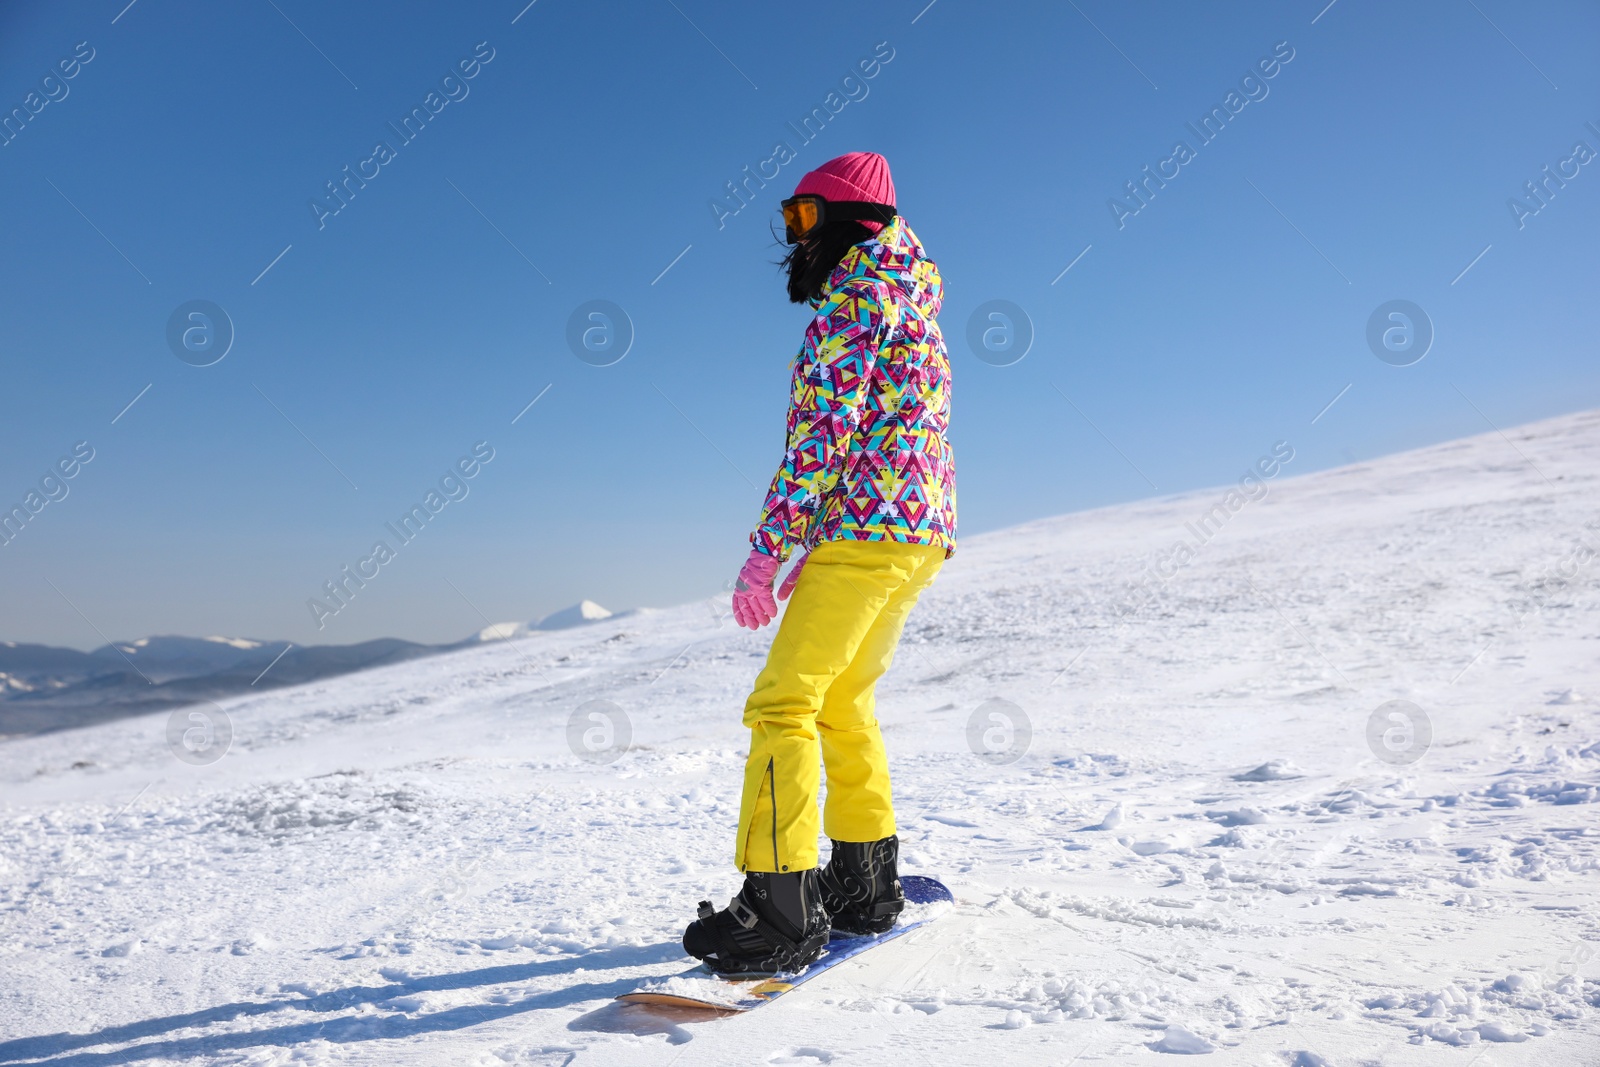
683;870;829;976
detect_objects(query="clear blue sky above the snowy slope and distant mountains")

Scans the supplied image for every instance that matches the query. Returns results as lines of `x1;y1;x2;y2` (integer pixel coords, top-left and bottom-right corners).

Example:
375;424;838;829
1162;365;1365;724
0;0;1600;648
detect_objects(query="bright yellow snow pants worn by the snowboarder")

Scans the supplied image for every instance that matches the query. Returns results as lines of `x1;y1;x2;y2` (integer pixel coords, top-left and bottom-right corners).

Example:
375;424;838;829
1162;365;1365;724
734;541;944;872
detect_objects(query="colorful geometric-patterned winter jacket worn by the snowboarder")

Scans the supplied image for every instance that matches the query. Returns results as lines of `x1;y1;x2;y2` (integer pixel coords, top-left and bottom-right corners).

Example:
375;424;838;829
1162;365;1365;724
750;219;955;560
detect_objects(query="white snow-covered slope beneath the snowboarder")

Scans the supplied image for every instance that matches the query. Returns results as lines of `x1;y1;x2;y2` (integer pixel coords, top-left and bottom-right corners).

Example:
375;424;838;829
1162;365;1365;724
0;413;1600;1067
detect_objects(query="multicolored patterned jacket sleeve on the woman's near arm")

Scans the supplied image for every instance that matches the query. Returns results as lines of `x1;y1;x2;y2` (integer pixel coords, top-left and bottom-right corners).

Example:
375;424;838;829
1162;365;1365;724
750;278;891;560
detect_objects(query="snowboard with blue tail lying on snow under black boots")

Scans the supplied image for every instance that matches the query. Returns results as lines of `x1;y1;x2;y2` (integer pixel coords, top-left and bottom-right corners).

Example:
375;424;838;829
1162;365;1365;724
618;875;955;1013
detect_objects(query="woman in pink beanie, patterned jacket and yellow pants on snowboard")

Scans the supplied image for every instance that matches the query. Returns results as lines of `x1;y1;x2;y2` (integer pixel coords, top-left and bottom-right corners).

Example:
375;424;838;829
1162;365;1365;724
683;152;955;974
